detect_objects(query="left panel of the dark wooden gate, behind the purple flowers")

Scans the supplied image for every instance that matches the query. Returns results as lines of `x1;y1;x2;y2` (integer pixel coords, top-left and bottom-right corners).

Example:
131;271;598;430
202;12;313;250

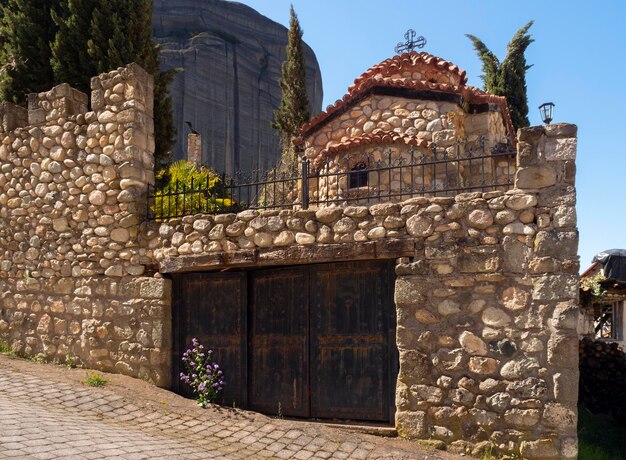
172;272;247;407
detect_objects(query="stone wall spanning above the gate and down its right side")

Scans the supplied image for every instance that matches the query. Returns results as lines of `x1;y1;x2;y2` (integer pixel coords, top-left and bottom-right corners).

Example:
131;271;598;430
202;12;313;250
144;125;578;458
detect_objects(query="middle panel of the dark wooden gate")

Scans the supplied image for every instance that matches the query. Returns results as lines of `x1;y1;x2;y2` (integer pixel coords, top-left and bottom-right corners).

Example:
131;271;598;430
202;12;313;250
248;267;309;417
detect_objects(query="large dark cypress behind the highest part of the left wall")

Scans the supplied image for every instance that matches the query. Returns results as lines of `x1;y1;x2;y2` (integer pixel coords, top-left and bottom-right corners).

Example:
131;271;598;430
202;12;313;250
52;0;176;173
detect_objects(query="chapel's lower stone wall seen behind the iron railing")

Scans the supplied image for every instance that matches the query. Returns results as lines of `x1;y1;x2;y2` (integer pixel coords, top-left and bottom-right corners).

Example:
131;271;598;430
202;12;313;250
308;143;515;204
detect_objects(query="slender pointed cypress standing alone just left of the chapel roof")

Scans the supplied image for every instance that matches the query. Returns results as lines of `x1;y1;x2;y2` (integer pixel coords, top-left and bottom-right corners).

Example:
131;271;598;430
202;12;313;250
272;5;310;172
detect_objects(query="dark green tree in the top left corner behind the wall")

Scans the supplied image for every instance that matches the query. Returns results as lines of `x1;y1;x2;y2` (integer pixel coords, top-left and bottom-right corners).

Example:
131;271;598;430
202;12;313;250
0;0;60;104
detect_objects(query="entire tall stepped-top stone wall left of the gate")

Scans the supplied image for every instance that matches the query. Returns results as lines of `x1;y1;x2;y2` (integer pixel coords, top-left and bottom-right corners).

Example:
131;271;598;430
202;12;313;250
0;64;171;385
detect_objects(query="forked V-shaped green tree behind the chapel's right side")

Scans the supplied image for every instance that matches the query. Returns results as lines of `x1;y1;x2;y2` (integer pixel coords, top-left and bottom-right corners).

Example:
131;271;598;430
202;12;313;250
466;21;534;129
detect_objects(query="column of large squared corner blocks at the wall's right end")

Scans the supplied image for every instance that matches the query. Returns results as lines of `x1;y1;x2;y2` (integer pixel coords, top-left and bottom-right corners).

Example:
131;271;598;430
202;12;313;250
515;124;579;458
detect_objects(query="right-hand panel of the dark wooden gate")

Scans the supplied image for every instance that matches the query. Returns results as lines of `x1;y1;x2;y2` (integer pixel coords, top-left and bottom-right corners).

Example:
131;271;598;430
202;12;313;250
311;262;395;421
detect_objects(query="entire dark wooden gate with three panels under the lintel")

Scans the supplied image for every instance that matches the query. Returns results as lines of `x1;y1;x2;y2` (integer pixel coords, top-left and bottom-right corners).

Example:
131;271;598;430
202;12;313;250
173;261;398;422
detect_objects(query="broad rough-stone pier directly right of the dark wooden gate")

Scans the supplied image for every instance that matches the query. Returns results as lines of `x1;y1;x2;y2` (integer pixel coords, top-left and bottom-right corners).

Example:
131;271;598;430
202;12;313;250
395;124;579;458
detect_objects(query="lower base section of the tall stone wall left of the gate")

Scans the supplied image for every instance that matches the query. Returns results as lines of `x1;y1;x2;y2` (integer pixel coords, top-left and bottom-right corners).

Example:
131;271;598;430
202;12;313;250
0;276;172;387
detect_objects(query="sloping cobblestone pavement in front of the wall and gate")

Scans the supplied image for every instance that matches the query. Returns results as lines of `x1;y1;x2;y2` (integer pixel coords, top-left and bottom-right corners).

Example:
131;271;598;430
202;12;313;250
0;356;460;460
